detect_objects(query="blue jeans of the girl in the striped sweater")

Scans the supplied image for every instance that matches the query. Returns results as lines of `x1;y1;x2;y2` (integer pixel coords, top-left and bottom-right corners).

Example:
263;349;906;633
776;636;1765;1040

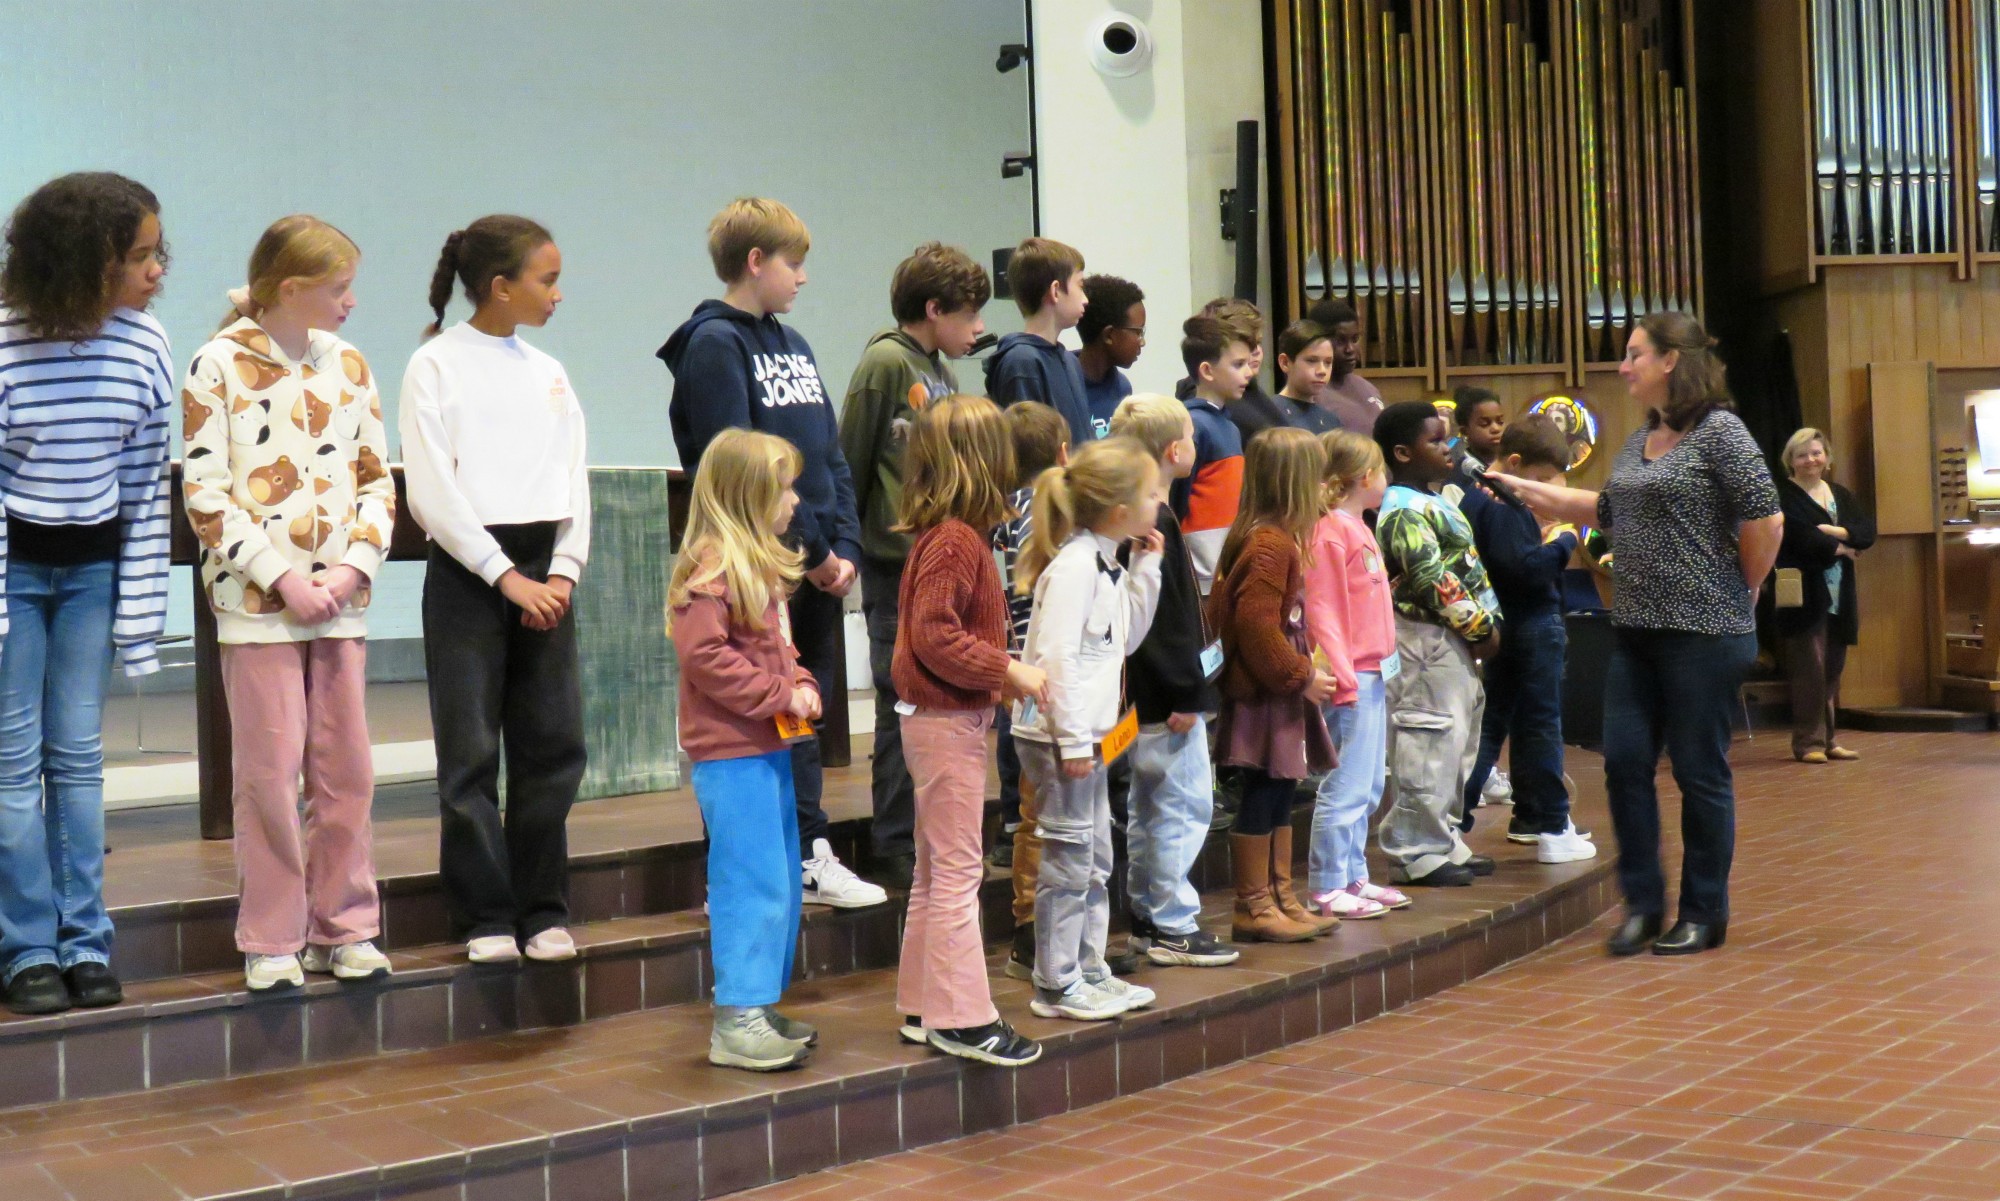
0;562;118;981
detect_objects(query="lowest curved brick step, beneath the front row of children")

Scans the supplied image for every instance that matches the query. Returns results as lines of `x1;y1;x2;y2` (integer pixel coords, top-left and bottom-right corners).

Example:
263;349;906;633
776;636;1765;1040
0;824;1616;1201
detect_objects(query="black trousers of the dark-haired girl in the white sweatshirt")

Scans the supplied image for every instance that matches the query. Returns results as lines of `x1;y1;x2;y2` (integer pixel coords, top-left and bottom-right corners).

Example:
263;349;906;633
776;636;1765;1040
424;522;584;939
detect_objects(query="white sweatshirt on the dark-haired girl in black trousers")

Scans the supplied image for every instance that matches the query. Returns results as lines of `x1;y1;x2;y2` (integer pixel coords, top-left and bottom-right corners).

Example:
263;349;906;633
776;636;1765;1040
396;322;590;584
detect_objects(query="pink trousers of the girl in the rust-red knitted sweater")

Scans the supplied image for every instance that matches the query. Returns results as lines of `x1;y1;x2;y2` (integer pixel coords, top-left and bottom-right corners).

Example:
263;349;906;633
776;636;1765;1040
896;709;1000;1031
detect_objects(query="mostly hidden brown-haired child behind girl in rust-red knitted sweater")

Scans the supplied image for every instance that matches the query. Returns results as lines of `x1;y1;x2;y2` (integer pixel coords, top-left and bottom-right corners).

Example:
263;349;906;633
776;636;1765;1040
994;400;1070;981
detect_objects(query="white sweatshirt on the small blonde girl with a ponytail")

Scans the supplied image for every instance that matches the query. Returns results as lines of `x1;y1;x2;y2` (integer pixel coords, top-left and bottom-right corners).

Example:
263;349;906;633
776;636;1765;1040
1014;530;1160;759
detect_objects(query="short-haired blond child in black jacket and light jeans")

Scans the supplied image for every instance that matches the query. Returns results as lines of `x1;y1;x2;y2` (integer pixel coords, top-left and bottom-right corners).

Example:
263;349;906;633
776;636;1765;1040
1112;396;1238;967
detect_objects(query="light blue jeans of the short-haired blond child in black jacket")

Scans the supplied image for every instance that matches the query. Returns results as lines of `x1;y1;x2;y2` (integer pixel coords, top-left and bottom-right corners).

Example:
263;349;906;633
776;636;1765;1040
1126;717;1216;935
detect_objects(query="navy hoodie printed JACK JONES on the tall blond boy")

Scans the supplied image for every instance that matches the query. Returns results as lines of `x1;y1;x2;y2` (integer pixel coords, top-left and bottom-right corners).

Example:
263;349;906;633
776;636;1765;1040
658;300;862;570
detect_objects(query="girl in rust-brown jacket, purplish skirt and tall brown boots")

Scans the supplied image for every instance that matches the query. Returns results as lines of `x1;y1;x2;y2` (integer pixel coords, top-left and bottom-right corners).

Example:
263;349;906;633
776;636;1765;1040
1208;428;1340;943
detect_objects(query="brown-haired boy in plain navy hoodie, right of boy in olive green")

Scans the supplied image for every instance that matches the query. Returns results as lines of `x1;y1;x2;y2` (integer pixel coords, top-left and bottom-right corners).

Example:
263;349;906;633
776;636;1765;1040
986;238;1096;446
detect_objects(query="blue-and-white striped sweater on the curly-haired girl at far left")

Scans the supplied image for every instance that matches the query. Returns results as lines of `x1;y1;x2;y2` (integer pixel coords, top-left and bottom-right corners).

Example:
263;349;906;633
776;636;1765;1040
0;308;176;677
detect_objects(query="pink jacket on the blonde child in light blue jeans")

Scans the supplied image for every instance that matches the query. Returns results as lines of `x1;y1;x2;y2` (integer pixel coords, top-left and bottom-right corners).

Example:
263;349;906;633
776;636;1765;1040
1306;508;1396;705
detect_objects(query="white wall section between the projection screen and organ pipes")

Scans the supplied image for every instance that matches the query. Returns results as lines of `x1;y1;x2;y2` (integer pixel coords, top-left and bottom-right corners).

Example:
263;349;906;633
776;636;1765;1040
1032;0;1270;390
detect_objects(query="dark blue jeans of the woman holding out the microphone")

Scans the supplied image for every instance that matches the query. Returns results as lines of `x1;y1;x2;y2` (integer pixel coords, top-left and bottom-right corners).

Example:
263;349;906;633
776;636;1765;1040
1604;629;1756;923
